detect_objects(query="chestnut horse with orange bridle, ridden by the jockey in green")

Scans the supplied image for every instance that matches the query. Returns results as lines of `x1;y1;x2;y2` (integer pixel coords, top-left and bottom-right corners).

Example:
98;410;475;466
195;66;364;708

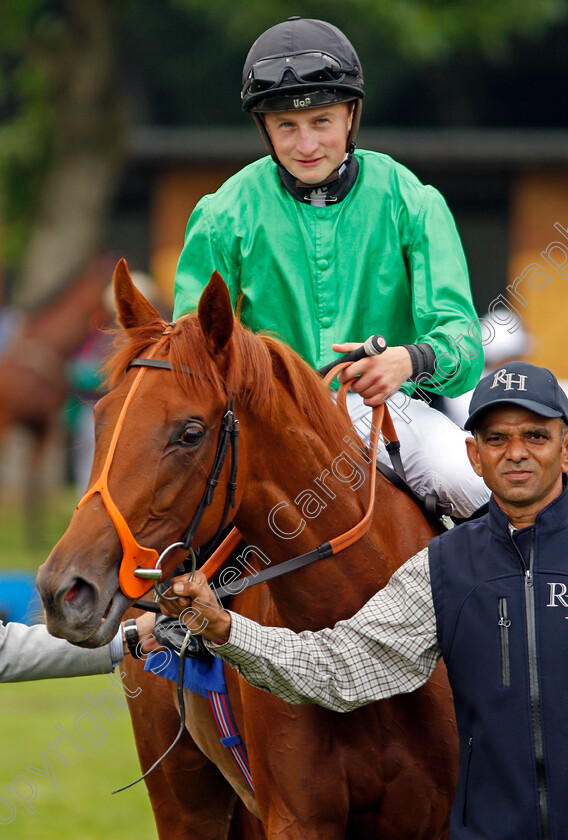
38;262;457;840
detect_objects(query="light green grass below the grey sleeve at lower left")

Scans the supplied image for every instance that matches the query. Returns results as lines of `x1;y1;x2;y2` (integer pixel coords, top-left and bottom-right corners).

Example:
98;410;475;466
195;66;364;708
0;675;157;840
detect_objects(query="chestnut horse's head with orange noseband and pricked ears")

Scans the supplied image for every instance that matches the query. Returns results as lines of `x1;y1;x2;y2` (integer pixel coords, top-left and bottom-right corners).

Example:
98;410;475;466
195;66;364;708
37;260;243;647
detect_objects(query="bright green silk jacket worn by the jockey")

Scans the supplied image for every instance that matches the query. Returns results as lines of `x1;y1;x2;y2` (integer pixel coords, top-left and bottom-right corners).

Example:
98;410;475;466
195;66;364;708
174;150;483;396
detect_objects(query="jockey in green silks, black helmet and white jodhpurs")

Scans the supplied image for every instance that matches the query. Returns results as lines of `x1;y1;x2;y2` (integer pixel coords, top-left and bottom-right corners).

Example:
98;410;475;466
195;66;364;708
174;17;488;517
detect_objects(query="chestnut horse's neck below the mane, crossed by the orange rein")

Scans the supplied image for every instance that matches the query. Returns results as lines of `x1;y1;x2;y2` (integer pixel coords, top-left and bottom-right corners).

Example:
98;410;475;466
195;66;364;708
235;400;429;629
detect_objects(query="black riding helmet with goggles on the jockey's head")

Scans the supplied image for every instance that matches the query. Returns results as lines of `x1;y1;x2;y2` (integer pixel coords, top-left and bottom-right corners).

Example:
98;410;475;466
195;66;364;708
241;17;365;159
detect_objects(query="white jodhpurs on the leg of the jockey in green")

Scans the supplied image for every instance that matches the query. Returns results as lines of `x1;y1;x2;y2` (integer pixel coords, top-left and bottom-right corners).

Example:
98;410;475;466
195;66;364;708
347;391;490;518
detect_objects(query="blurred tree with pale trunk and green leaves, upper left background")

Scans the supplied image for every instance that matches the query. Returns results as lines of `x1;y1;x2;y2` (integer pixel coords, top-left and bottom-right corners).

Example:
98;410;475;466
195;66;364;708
0;0;125;307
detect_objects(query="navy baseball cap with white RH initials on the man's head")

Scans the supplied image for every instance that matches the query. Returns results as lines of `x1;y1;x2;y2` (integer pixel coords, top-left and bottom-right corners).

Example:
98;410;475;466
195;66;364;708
464;362;568;431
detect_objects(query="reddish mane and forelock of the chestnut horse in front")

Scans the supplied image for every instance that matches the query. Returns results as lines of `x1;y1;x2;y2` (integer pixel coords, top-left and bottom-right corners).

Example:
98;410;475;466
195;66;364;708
104;314;350;449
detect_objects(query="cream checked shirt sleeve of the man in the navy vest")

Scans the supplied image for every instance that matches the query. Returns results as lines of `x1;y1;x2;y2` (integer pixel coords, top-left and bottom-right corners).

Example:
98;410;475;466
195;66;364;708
208;549;440;712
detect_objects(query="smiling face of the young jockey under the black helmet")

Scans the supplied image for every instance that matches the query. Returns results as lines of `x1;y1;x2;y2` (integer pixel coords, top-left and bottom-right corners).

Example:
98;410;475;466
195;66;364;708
263;102;353;184
